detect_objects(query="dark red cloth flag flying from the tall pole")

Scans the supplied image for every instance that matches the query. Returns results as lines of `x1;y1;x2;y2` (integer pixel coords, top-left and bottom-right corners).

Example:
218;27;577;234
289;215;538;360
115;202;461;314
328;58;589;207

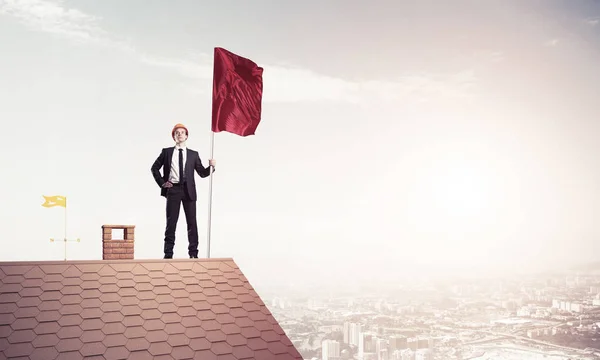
212;47;263;136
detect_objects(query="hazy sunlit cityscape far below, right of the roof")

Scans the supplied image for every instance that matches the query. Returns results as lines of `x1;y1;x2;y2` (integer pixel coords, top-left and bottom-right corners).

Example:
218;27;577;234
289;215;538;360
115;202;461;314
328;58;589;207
269;263;600;360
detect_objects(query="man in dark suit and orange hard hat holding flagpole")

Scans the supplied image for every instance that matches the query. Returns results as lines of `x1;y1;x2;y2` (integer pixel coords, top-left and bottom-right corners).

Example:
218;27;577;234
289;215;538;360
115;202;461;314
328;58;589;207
151;124;215;259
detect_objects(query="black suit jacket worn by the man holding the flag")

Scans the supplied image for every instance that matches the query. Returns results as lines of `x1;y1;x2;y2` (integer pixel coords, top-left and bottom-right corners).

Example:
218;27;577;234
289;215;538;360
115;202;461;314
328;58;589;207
150;146;215;201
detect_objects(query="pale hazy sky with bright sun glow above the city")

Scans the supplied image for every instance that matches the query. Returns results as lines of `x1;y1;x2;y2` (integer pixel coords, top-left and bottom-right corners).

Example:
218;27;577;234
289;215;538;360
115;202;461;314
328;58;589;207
0;0;600;287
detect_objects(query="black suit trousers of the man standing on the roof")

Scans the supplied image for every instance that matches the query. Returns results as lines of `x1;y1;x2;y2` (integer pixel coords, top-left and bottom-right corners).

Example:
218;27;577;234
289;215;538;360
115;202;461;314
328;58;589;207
164;184;198;258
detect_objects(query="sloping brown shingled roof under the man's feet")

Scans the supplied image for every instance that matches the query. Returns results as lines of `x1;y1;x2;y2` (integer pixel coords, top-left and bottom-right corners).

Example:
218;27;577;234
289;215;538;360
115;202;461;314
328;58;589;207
0;259;302;360
